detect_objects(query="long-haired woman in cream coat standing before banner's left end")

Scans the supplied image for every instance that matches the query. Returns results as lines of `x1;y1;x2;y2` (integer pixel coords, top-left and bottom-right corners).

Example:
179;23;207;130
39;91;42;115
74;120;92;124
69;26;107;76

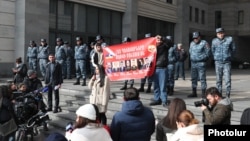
88;65;110;125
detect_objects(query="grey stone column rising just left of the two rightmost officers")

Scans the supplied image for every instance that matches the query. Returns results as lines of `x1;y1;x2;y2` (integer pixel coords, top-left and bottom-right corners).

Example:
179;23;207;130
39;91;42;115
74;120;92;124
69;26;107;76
174;0;189;69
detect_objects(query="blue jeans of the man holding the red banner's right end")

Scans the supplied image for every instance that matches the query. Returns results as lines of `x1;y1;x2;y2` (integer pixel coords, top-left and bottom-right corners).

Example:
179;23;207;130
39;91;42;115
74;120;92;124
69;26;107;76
153;68;168;103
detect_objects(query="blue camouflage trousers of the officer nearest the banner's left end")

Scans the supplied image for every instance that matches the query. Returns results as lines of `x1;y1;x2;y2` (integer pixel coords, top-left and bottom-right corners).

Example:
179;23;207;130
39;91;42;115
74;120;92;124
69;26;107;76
76;60;87;79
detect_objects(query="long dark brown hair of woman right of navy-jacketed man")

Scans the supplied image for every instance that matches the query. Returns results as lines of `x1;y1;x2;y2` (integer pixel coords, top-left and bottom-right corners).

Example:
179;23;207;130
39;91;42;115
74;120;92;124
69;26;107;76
163;98;186;129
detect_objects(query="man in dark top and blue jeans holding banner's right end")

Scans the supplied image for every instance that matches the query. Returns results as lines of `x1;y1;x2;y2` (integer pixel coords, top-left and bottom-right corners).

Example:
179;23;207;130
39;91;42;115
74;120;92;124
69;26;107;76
150;35;169;107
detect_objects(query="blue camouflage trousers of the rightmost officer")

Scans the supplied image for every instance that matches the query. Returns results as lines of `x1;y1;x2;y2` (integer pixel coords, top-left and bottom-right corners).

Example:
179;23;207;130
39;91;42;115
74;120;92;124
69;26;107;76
215;61;231;94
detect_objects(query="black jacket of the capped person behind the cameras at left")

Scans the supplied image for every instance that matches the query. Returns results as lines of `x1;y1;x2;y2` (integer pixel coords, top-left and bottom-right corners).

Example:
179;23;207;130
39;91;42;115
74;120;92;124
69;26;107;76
23;77;43;93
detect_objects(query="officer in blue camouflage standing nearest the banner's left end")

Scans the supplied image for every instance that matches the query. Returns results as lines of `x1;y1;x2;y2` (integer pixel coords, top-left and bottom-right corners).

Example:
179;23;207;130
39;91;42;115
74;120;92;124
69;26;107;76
73;37;89;86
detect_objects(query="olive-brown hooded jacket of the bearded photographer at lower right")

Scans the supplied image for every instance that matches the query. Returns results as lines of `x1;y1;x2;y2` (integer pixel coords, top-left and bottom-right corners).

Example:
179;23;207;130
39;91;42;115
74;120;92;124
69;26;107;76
204;98;233;125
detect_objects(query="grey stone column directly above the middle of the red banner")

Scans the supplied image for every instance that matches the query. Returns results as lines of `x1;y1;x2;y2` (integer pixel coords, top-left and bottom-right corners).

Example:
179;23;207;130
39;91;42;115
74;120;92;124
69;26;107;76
122;0;138;40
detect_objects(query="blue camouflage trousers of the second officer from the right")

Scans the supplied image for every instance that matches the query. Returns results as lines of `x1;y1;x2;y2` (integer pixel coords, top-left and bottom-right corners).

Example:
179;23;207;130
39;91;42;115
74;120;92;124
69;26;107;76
191;62;207;90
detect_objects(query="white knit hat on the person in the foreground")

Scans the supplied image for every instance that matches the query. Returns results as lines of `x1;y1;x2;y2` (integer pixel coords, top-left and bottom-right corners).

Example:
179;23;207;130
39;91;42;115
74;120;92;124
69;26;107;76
76;104;96;120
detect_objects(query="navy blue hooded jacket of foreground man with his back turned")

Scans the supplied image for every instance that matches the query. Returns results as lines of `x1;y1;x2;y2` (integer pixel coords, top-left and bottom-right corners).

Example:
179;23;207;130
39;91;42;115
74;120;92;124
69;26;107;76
110;100;155;141
